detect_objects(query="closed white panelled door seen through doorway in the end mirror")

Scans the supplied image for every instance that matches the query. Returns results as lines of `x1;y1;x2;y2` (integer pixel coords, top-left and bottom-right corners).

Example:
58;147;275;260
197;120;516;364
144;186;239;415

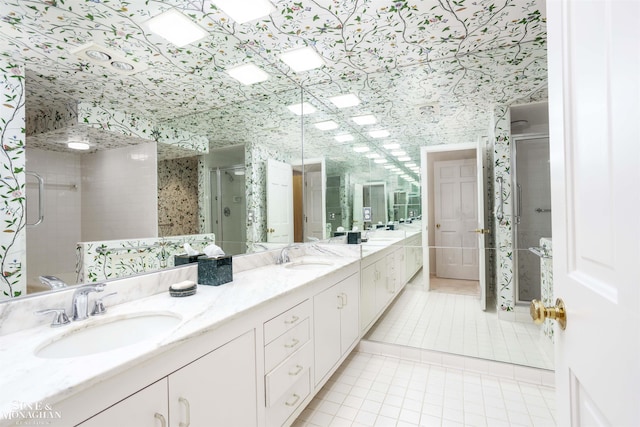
434;159;479;280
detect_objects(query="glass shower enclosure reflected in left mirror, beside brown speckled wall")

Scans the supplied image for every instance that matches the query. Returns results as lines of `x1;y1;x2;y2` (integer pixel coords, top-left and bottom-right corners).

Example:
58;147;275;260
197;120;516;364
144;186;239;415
210;166;247;255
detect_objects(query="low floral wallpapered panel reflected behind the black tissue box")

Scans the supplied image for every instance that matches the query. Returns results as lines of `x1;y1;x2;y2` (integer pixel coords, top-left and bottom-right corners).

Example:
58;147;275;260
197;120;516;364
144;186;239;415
76;234;215;283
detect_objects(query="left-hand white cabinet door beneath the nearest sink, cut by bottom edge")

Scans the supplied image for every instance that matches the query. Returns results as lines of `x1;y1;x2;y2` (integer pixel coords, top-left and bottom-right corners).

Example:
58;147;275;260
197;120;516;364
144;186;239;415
79;378;169;427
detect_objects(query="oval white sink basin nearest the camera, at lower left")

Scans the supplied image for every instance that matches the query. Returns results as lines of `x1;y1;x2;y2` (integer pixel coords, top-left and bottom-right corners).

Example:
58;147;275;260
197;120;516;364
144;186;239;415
35;313;182;359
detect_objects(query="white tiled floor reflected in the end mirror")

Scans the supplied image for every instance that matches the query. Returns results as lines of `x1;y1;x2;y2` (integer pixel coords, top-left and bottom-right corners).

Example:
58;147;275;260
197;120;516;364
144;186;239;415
366;273;554;369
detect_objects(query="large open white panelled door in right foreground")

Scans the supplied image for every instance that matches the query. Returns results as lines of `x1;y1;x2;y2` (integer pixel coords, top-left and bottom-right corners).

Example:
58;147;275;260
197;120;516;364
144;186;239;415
548;0;640;426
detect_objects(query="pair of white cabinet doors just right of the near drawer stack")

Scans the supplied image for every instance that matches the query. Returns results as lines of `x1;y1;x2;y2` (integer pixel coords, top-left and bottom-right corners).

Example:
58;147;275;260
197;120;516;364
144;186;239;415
313;274;360;384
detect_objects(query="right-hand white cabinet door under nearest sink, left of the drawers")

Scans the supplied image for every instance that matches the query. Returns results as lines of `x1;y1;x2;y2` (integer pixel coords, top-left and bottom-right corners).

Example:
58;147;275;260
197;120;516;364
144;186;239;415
169;331;257;427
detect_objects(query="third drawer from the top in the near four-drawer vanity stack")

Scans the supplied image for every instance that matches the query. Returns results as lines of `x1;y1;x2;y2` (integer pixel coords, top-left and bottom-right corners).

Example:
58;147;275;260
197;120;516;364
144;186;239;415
265;341;313;407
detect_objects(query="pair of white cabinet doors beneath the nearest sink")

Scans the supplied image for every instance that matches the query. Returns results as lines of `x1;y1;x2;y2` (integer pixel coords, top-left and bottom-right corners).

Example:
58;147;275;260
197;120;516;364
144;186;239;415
79;331;257;427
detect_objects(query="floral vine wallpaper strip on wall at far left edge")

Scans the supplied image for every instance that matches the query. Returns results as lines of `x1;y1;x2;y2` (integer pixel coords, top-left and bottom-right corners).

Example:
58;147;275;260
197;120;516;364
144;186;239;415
0;55;27;299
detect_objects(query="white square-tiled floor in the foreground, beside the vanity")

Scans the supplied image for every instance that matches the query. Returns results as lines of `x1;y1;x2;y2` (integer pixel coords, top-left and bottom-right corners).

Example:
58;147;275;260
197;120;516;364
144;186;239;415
293;352;556;427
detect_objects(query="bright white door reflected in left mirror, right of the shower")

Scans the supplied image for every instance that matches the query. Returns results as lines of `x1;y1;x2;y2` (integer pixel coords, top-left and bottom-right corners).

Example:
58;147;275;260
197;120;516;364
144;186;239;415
267;159;293;243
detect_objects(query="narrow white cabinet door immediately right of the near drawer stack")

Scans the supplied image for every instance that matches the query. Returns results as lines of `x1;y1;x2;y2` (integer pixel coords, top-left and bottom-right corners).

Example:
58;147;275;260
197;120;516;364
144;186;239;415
313;285;342;384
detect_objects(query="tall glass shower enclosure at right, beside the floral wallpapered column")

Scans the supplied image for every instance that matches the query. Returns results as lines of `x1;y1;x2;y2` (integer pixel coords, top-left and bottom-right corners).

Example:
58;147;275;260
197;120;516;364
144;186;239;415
512;136;551;303
